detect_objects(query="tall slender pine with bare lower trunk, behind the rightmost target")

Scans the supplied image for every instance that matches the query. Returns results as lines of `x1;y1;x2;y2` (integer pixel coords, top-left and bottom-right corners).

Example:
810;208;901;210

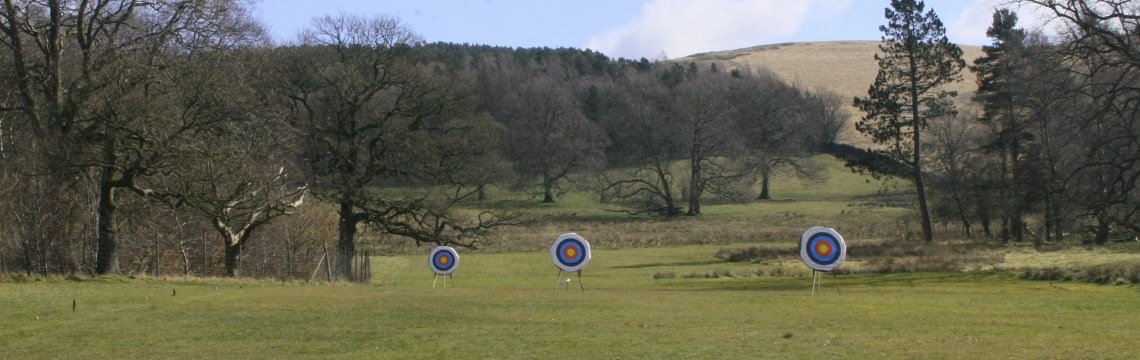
855;0;966;242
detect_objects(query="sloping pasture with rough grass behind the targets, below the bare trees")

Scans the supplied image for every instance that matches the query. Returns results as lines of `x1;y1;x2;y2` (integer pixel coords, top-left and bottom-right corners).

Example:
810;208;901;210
412;155;916;254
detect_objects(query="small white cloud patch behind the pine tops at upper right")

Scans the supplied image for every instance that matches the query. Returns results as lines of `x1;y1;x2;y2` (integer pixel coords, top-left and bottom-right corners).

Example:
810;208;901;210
946;0;1053;44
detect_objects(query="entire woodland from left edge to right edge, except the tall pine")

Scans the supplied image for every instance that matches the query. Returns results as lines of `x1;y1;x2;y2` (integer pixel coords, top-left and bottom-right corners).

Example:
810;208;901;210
0;0;1140;279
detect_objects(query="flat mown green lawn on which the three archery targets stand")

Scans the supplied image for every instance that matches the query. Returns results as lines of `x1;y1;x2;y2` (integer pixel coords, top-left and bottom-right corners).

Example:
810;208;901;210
0;246;1140;359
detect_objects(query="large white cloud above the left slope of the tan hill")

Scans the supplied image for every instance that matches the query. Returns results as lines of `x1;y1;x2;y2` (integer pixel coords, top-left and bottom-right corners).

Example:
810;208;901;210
586;0;825;58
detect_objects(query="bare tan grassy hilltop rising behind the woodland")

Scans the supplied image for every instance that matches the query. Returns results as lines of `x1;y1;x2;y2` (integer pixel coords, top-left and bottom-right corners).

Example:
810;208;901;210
678;41;982;144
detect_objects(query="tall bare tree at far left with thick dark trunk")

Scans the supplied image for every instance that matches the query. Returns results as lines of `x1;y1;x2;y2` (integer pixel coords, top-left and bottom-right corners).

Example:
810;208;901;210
0;0;261;273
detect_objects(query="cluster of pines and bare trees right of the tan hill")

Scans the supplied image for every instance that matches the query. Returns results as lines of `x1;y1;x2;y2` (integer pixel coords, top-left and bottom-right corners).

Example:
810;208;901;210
848;0;1140;245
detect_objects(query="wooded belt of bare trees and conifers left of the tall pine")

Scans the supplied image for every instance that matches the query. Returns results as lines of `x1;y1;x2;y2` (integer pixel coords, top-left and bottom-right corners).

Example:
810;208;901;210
0;0;845;279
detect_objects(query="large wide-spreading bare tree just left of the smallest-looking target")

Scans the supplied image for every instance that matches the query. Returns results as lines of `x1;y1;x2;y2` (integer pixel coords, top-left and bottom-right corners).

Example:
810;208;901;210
278;15;513;278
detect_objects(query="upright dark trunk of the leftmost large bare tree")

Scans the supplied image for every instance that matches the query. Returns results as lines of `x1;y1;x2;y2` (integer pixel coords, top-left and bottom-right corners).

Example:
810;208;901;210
95;140;119;275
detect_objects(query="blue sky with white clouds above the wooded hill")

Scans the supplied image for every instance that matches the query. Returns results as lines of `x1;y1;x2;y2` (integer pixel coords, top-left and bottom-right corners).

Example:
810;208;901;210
253;0;1048;59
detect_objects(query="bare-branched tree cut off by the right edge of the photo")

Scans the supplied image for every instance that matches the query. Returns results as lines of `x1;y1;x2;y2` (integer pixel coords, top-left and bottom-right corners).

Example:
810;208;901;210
1025;0;1140;244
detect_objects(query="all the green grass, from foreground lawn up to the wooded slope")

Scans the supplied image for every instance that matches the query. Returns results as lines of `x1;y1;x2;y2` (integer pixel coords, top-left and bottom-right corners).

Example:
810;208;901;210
0;152;1140;359
